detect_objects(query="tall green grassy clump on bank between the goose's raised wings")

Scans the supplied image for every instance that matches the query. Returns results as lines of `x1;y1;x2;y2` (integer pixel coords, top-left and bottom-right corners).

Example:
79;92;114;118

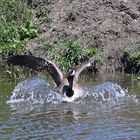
44;37;81;70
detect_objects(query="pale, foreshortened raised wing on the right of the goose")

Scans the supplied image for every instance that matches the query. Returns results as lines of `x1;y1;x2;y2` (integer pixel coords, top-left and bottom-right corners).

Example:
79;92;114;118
75;61;91;81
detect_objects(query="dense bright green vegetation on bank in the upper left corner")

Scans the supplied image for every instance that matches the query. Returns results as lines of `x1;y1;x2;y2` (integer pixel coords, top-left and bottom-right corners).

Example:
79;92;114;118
0;0;37;55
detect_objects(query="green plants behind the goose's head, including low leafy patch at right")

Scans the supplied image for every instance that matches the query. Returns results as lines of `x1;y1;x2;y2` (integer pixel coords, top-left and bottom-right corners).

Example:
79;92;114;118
42;34;101;71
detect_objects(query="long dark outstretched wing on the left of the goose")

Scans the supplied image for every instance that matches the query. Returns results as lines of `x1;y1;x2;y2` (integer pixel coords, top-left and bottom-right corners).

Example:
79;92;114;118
7;55;63;86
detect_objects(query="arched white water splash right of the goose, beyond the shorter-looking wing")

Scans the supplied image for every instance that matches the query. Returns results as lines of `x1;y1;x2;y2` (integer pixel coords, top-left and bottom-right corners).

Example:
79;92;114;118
86;82;139;104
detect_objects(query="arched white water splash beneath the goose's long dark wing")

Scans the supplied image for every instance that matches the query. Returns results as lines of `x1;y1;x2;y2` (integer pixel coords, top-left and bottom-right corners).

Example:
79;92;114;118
7;78;61;104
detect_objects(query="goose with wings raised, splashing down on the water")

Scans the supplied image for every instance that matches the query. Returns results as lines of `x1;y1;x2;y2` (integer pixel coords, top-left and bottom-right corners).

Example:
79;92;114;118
7;55;91;101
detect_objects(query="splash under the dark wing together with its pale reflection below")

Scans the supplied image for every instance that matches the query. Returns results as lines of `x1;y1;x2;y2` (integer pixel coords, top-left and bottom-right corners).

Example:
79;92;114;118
7;78;61;113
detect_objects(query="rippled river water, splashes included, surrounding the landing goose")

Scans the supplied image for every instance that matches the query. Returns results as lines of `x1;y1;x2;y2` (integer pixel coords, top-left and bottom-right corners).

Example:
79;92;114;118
0;71;140;140
